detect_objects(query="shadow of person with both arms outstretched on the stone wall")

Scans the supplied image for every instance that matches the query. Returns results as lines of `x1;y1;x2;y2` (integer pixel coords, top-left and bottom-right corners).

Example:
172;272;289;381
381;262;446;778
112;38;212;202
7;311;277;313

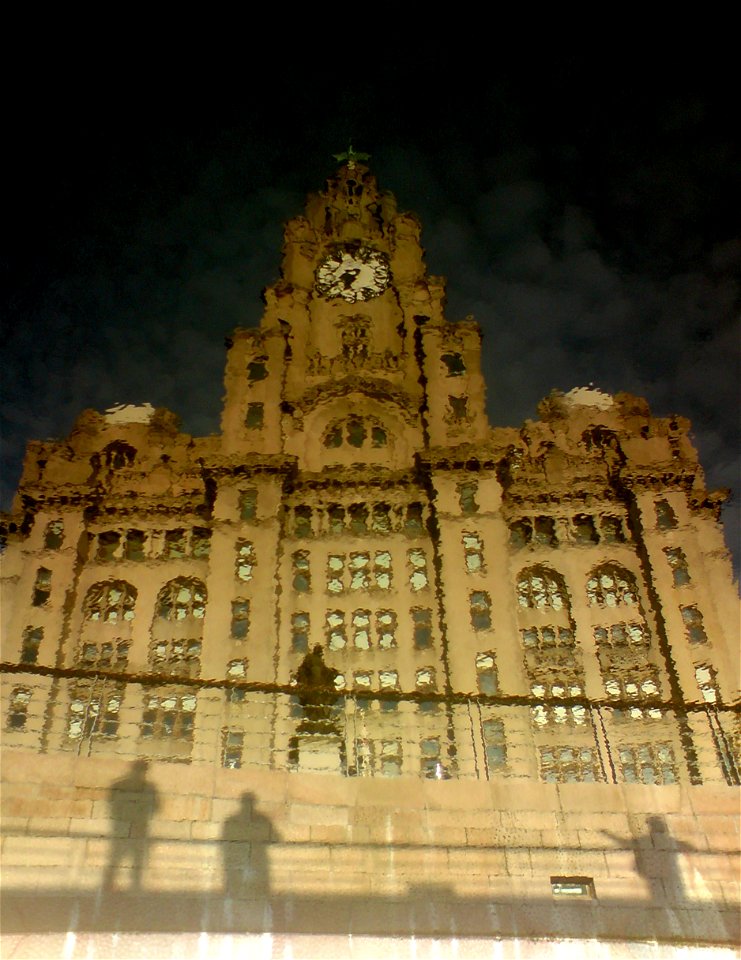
601;816;705;904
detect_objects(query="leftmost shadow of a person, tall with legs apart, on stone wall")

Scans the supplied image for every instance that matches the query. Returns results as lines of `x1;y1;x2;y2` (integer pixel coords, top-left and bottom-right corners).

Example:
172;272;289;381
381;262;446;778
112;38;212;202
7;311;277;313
103;760;159;890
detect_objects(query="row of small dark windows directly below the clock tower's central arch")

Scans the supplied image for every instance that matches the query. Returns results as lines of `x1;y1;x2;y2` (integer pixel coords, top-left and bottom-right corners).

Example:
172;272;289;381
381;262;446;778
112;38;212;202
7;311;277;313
282;502;427;538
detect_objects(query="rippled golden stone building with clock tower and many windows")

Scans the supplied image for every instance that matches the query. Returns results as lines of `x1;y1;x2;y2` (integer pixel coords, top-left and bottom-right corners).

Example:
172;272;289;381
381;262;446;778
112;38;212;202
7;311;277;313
3;160;739;784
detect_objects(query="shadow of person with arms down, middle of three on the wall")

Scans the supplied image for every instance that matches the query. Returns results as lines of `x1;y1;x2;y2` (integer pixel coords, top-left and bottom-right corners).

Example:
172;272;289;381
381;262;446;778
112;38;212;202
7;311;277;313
221;792;273;900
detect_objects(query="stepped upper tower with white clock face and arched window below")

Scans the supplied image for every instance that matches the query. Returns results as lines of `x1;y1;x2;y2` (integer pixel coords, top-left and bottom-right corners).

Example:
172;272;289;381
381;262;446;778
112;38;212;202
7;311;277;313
223;158;488;471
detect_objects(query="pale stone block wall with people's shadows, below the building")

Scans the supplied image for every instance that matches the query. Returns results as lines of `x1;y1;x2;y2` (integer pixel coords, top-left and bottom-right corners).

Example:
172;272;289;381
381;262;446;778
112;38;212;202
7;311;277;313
2;750;739;957
